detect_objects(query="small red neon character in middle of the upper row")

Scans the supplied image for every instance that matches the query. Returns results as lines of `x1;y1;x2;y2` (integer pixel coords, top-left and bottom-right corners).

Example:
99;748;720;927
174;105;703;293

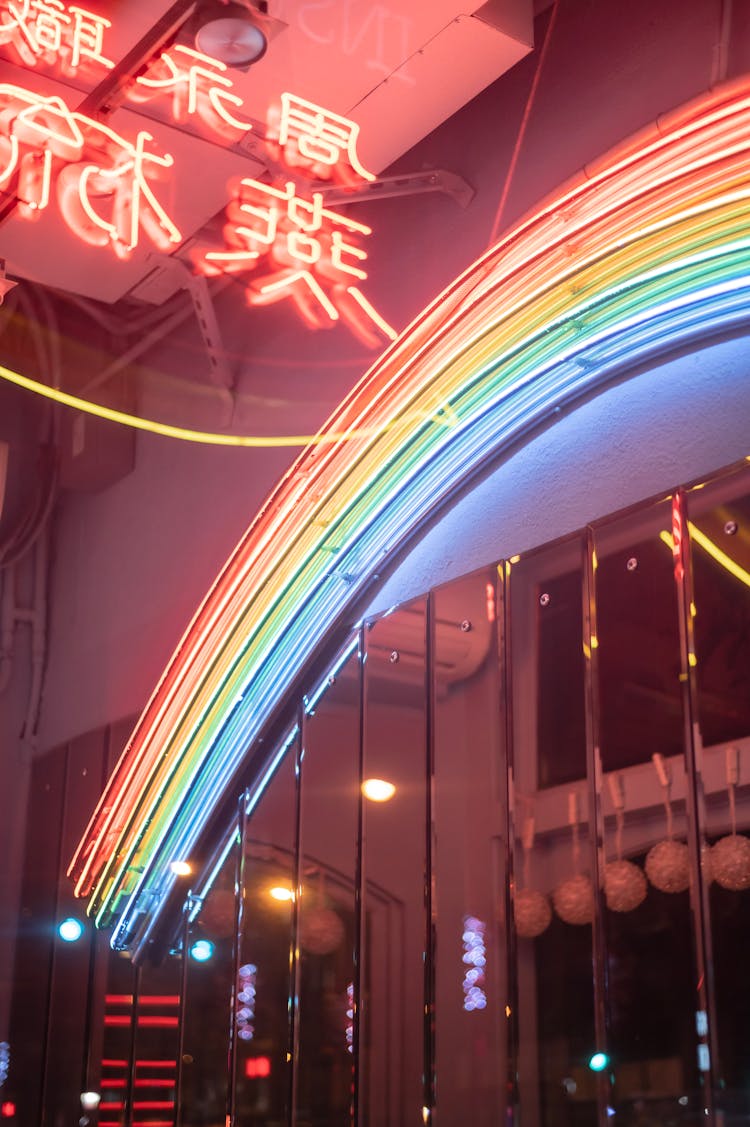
131;46;253;133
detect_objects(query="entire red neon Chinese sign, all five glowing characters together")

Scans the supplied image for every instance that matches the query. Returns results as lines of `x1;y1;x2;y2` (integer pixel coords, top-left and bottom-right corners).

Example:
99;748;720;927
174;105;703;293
0;0;396;338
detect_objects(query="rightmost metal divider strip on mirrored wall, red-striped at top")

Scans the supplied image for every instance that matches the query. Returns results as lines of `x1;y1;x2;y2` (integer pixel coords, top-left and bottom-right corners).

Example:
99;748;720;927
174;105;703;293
672;489;718;1124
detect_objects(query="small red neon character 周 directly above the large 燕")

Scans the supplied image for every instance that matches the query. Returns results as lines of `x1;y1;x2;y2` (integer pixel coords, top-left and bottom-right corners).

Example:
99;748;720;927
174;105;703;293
267;94;374;185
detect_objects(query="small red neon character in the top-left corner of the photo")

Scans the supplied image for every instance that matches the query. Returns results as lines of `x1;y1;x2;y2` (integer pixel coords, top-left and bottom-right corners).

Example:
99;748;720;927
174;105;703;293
0;0;114;73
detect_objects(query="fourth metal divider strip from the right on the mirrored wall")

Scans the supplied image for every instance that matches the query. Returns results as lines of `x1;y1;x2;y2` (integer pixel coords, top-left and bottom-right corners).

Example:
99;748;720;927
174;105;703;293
422;593;436;1124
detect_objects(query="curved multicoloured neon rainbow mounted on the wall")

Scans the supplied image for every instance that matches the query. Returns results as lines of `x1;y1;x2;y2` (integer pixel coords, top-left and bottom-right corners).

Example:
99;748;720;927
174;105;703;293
70;80;750;946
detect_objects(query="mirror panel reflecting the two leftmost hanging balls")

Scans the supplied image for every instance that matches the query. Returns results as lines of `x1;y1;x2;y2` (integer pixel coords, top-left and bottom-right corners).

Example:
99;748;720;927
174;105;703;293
509;541;599;1127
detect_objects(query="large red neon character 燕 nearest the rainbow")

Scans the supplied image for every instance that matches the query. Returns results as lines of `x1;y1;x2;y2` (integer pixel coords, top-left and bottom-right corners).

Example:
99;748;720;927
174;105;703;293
198;179;396;347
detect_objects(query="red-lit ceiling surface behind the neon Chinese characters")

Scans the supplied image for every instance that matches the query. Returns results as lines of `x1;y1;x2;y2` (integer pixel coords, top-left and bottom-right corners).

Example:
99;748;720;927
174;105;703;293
0;0;532;304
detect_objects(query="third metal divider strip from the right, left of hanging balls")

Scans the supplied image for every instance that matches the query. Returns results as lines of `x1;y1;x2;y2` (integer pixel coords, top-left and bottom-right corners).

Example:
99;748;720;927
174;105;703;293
495;560;521;1125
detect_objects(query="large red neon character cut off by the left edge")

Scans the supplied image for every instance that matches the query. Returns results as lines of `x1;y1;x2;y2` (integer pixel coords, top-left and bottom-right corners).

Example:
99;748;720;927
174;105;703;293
0;83;182;257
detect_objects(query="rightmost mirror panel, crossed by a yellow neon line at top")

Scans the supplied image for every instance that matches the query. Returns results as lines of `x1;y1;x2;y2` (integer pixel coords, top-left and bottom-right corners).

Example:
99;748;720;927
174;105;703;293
688;472;750;1122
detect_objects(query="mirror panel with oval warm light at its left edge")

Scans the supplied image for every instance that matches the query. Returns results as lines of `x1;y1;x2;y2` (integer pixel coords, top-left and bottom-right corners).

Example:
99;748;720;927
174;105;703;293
359;600;430;1127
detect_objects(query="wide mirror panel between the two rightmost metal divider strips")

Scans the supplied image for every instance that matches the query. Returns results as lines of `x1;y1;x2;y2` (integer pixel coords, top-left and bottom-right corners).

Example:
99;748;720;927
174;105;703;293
594;499;703;1124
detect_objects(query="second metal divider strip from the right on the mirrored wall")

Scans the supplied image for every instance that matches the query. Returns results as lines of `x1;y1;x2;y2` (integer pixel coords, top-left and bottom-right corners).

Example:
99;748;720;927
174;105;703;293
583;527;611;1127
